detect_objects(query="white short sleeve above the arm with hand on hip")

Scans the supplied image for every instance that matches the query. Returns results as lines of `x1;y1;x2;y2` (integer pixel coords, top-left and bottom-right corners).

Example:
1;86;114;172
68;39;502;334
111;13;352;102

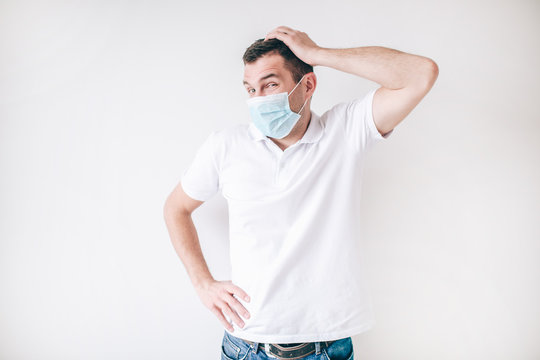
180;131;219;201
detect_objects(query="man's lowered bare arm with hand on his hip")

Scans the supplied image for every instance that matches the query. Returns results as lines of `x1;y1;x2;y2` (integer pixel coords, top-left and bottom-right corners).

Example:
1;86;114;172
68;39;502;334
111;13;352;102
163;183;249;332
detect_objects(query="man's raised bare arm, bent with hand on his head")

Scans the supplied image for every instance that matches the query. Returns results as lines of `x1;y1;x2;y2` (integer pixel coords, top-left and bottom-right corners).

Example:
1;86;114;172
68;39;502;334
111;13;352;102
266;26;439;135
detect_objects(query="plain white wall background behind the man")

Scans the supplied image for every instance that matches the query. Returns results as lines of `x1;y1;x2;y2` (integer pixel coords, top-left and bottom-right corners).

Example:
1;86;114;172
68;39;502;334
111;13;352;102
0;0;540;360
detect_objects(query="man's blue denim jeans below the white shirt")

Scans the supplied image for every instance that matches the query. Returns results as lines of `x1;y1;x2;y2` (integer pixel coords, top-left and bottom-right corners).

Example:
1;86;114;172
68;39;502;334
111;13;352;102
221;331;354;360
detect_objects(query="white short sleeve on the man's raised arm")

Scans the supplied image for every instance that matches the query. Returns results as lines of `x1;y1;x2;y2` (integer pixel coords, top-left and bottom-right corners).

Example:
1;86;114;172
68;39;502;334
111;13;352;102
344;89;394;151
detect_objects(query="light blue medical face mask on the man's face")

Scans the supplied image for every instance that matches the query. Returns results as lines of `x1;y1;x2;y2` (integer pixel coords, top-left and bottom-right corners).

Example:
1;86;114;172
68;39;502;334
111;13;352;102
246;75;309;139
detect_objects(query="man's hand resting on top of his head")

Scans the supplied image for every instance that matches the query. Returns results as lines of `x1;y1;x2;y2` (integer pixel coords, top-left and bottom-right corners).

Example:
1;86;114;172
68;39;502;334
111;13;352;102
264;26;322;66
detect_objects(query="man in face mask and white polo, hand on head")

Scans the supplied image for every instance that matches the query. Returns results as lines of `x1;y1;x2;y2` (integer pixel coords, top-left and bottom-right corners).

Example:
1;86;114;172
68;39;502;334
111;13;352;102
164;26;438;359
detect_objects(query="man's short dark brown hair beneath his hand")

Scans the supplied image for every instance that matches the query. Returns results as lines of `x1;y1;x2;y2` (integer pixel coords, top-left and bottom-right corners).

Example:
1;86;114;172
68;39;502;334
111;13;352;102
242;38;313;82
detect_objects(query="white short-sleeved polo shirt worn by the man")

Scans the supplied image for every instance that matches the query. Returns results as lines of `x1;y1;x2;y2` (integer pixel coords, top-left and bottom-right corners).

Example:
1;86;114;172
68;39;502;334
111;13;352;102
181;89;393;343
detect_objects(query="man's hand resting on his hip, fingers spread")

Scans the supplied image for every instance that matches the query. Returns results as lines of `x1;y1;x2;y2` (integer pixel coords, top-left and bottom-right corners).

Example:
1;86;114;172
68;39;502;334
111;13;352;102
195;280;250;332
